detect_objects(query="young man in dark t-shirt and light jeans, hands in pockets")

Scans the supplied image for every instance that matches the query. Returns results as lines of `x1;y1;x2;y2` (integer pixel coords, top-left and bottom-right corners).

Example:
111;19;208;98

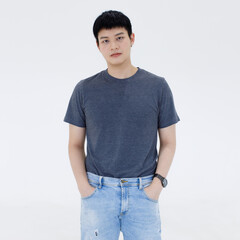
64;10;180;240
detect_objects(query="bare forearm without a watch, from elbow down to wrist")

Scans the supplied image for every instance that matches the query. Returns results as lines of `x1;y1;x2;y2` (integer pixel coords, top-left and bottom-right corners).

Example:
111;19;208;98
68;145;89;192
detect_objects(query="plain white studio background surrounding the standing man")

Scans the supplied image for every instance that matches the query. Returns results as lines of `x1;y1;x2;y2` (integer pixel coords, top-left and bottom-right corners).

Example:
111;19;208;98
0;0;240;240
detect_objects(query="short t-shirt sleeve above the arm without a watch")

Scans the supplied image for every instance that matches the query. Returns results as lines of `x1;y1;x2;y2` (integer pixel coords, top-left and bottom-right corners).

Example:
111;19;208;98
63;82;86;128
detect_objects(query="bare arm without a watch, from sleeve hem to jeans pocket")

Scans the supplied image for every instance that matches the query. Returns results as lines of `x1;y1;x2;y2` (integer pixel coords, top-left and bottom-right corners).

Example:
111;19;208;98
68;124;93;195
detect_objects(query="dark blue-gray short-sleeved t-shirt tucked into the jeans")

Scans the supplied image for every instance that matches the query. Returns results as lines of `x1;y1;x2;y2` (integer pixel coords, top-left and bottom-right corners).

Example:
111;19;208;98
64;67;180;178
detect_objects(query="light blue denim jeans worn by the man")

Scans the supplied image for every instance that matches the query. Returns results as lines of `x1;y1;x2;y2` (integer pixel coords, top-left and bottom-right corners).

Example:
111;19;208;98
80;172;161;240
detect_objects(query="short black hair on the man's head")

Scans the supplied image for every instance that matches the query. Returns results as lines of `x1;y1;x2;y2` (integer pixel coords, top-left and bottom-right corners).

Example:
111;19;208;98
93;10;132;45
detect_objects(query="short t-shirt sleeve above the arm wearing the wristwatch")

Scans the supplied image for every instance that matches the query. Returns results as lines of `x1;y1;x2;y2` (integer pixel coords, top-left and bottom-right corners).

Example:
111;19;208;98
158;78;180;128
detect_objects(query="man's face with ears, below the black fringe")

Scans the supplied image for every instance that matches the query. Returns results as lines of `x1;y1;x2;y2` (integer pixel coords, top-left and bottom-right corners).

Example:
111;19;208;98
97;27;135;66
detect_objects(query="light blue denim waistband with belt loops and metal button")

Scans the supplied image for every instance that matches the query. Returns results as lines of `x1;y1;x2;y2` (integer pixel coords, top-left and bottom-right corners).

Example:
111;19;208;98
87;172;154;189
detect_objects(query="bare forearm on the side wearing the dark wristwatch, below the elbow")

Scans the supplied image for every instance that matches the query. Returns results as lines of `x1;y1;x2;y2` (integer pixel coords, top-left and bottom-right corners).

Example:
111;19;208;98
153;143;176;189
